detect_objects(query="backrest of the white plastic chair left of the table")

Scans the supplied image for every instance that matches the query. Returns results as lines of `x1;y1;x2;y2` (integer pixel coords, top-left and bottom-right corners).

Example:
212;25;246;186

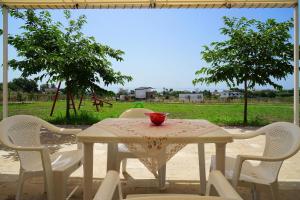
0;115;49;170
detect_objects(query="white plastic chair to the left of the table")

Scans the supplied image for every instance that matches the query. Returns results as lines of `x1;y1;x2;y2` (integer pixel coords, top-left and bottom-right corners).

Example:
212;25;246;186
0;115;82;200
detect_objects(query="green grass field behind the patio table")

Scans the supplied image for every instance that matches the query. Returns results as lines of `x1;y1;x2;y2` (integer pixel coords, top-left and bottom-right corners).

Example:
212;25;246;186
0;101;293;126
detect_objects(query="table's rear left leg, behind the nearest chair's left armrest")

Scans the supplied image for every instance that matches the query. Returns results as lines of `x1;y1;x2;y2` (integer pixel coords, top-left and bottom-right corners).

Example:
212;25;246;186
106;143;121;171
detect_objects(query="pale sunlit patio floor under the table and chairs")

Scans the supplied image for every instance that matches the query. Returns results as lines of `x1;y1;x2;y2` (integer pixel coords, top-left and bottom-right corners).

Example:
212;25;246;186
0;127;300;200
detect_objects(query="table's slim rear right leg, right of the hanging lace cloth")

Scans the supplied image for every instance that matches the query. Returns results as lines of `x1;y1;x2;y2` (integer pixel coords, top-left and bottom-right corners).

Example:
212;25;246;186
198;143;206;195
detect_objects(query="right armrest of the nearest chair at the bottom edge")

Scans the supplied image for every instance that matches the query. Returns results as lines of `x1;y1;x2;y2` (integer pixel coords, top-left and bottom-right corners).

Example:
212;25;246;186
206;170;242;200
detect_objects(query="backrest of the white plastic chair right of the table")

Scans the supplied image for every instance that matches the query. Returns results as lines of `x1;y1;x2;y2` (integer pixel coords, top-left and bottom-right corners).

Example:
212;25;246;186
258;122;300;181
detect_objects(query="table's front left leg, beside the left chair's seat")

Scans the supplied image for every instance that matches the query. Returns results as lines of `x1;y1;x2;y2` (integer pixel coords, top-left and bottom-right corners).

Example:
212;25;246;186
83;143;94;200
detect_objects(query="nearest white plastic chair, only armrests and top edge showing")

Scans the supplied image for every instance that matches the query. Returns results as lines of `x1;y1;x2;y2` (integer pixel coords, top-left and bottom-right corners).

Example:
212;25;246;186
94;171;242;200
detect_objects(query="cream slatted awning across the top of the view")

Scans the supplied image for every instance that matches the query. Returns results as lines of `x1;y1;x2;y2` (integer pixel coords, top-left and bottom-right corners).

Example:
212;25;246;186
0;0;298;9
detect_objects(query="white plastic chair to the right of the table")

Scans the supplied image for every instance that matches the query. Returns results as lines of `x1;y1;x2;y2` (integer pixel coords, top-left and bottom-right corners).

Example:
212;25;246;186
211;122;300;200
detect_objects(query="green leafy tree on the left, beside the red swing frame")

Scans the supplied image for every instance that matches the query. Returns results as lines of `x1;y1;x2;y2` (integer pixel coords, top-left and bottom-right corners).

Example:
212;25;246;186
9;10;132;120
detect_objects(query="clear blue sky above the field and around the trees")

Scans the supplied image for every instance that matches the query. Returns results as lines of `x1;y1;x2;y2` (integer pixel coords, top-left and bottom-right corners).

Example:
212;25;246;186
0;9;293;91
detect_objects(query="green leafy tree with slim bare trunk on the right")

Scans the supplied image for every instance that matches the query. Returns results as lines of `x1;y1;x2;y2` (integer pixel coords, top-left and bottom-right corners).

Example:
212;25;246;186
193;17;293;125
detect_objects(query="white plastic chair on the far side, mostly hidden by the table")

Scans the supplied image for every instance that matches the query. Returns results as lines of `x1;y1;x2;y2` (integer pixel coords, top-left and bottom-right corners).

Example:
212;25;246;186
112;108;166;189
